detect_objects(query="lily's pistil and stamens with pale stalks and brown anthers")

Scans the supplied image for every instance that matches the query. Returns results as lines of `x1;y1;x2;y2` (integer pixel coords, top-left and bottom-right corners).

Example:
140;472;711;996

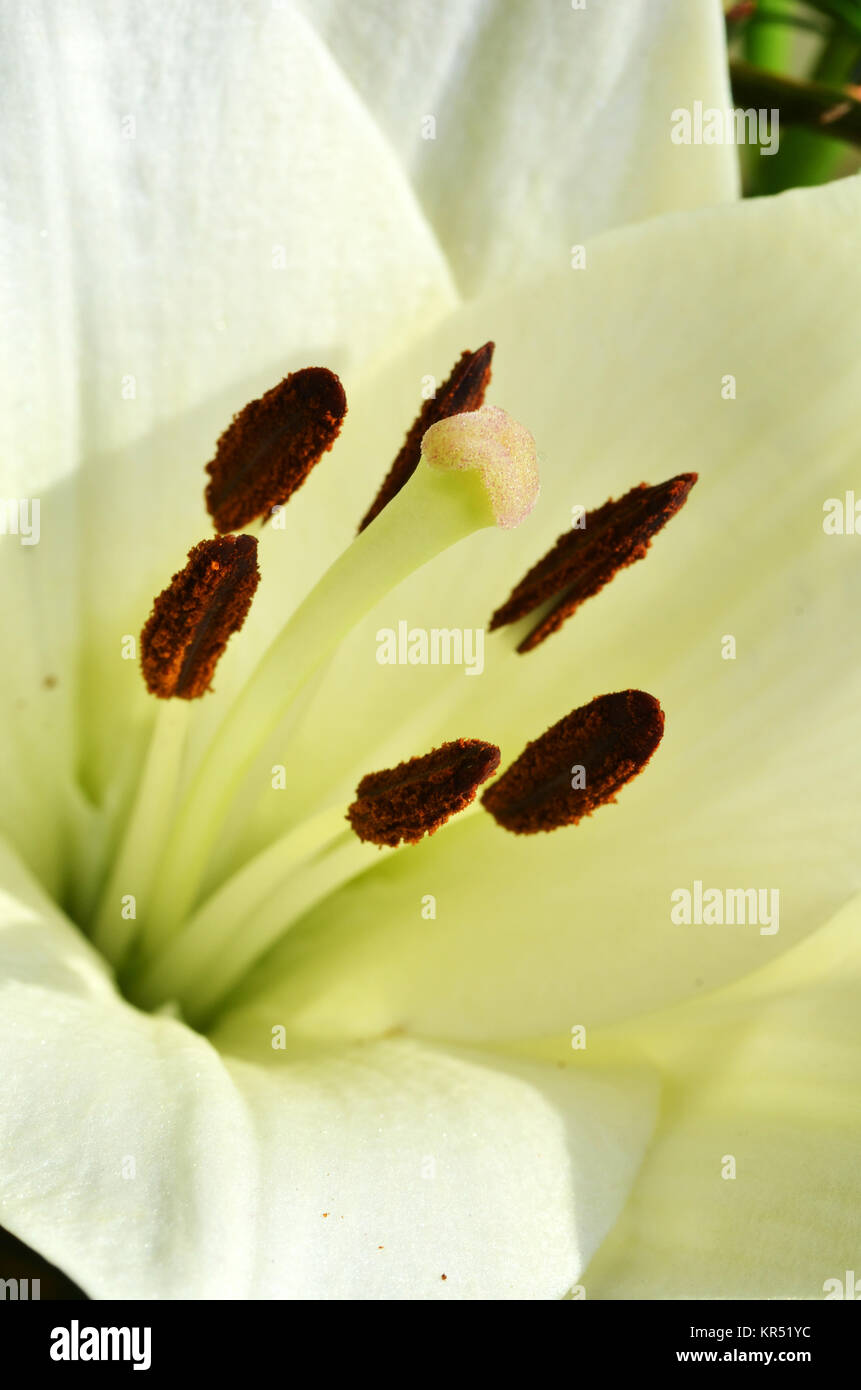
82;343;695;1027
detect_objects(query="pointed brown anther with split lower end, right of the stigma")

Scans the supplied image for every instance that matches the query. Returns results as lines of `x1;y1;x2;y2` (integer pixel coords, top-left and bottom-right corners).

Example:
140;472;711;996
490;473;697;652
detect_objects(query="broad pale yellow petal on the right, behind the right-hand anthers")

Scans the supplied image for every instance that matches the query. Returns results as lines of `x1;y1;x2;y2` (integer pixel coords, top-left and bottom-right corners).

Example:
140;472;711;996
226;179;861;1038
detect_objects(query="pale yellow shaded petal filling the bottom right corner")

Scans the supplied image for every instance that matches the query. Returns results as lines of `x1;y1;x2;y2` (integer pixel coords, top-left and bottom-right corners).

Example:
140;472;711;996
584;899;861;1298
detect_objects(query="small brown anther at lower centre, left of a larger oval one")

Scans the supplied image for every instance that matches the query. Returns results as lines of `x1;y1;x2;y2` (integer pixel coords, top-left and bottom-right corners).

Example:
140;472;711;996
346;738;499;848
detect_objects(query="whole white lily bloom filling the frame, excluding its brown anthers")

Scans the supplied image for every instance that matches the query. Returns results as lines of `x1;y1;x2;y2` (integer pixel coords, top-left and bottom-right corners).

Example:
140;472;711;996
0;3;861;1298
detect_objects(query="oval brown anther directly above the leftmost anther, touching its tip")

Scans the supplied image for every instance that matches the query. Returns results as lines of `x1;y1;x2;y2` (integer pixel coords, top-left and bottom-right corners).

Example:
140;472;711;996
204;367;346;532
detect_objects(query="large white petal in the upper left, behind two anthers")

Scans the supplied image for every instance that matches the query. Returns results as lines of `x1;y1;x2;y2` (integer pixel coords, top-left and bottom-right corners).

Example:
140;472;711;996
0;0;455;795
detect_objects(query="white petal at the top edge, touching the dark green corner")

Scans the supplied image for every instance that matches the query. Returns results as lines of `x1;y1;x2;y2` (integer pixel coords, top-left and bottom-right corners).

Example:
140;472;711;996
300;0;739;293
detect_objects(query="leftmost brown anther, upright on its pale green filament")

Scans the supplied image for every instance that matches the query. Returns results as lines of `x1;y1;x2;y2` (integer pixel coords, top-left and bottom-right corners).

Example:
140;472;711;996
140;535;260;699
